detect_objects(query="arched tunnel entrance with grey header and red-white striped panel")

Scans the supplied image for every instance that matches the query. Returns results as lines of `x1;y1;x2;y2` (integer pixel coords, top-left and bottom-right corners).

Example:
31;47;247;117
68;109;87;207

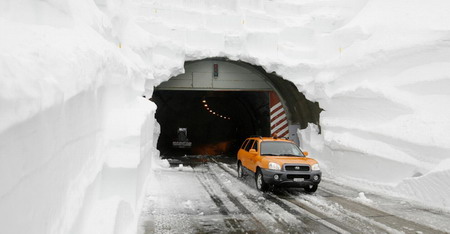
152;58;320;155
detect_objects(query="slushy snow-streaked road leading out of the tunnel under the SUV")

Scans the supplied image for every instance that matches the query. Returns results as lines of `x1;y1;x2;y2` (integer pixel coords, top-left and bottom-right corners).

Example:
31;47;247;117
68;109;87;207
141;156;450;233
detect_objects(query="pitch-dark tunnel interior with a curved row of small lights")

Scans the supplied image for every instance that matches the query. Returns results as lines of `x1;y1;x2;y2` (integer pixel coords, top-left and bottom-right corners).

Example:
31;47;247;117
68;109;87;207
152;90;270;155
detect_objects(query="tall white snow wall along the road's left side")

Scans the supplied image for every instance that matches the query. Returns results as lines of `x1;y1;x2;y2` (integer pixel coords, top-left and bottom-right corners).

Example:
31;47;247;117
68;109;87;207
0;1;159;233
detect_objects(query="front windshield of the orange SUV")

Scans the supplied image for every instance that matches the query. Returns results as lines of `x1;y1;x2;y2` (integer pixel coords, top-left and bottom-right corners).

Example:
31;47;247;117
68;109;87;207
261;141;305;157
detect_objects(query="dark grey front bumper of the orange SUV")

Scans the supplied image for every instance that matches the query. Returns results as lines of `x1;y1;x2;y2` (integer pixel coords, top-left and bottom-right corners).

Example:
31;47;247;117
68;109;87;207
261;169;322;187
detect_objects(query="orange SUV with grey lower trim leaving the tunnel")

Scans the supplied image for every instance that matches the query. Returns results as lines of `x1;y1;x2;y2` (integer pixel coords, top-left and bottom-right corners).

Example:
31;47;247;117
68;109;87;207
237;137;322;193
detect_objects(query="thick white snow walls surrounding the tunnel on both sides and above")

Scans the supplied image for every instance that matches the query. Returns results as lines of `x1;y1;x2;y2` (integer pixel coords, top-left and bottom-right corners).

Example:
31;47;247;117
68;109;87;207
0;0;450;233
